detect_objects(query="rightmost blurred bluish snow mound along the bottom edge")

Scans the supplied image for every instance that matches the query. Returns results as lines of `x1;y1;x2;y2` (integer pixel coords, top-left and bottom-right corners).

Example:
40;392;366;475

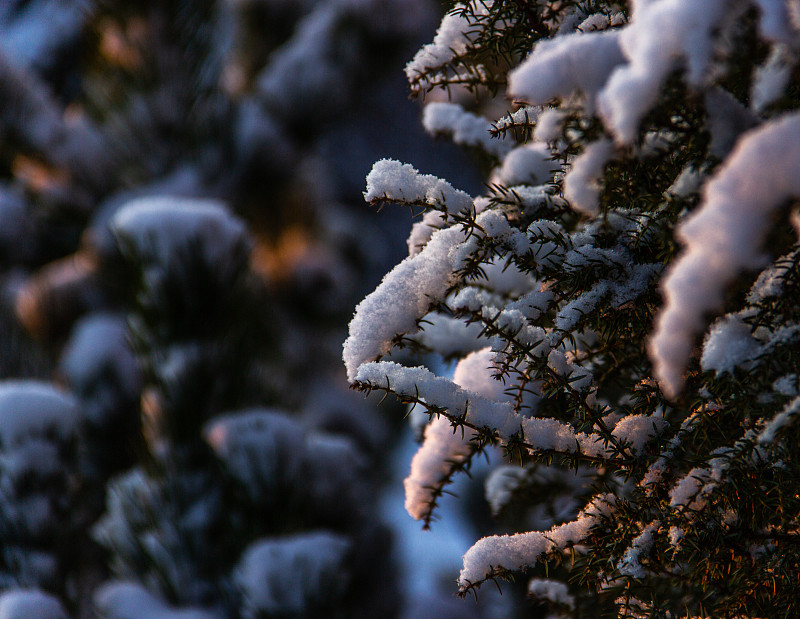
234;531;351;619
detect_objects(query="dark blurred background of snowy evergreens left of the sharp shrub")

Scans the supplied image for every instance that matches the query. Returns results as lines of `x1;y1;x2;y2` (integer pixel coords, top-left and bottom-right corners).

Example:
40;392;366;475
0;0;518;619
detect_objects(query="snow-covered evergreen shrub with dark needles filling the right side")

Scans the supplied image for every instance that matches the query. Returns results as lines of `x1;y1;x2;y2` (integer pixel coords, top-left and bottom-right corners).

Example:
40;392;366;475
343;0;800;617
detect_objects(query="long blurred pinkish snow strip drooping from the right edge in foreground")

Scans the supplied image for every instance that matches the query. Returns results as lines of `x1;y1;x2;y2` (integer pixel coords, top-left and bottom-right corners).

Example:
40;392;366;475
649;114;800;397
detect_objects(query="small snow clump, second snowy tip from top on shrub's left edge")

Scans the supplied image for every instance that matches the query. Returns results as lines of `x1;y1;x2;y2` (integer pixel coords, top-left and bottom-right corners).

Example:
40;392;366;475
422;101;513;158
